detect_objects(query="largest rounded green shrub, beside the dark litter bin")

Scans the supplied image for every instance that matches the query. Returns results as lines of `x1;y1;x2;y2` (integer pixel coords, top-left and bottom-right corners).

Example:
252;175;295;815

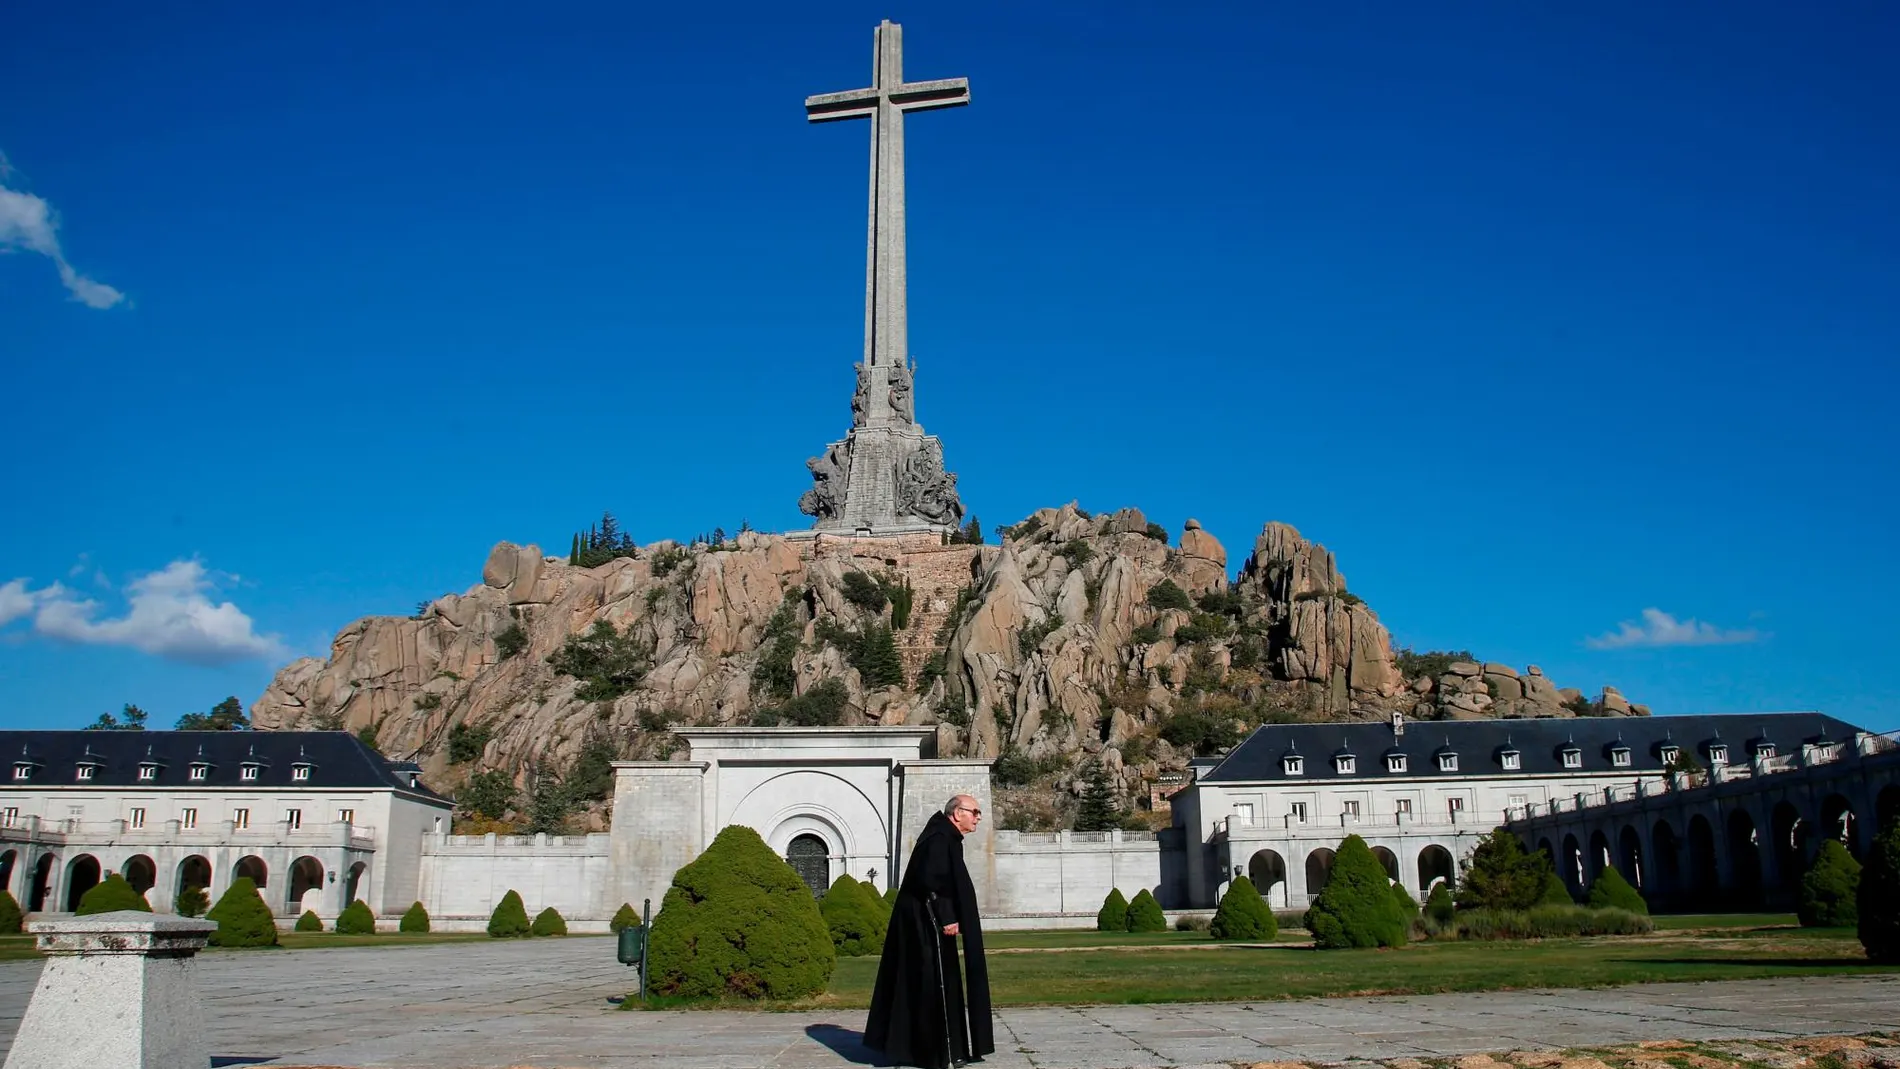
648;824;838;999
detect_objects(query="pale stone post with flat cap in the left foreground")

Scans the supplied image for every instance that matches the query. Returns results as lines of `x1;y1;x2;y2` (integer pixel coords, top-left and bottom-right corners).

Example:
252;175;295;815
6;910;217;1069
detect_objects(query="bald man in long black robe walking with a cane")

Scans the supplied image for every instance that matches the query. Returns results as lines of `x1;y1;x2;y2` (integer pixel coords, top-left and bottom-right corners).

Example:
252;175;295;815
865;794;996;1069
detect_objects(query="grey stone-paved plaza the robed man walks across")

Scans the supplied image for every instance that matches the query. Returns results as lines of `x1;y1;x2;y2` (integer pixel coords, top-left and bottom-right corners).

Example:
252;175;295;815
0;938;1900;1069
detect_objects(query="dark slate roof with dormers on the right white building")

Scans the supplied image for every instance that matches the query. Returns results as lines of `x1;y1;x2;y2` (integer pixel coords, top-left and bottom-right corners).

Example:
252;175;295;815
1193;712;1860;782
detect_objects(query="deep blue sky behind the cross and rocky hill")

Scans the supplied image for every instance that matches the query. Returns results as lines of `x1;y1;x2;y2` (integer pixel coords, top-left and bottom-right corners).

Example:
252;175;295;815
0;2;1900;729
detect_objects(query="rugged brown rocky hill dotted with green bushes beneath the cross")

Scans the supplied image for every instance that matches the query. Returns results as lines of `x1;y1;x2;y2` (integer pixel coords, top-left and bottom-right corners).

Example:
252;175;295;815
253;505;1647;820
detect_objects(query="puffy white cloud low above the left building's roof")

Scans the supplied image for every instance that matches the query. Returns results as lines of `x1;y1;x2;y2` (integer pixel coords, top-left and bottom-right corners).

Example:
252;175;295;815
0;560;283;665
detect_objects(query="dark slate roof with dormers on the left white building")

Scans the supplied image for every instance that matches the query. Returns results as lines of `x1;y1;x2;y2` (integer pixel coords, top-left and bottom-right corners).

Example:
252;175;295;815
0;731;448;803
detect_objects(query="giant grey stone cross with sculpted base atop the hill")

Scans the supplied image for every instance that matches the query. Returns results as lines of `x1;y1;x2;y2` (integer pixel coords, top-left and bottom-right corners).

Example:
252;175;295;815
798;21;969;534
